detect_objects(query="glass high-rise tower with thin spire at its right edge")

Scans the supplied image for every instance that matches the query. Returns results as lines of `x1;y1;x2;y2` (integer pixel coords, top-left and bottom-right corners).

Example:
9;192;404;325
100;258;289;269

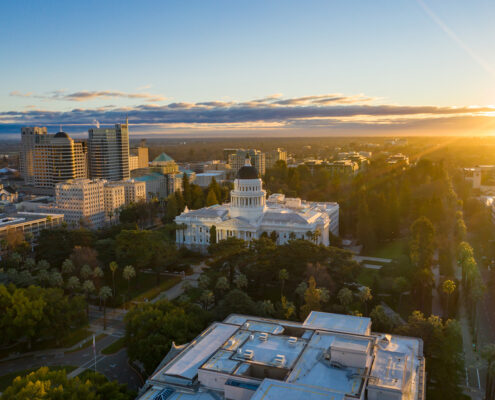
88;119;130;181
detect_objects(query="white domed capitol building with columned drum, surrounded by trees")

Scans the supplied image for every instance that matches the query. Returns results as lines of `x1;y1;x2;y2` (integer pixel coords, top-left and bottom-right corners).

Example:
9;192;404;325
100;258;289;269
175;158;339;248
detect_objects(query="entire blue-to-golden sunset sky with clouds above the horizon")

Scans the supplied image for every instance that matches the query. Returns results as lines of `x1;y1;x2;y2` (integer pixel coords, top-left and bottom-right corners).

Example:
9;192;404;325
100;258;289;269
0;0;495;136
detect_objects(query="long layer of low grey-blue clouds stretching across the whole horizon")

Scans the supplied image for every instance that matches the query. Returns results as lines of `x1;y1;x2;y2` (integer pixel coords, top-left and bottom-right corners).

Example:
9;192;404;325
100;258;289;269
0;91;495;132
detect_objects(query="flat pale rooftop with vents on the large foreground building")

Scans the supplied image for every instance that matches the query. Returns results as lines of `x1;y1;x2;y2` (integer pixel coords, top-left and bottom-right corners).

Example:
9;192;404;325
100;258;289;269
140;312;424;400
